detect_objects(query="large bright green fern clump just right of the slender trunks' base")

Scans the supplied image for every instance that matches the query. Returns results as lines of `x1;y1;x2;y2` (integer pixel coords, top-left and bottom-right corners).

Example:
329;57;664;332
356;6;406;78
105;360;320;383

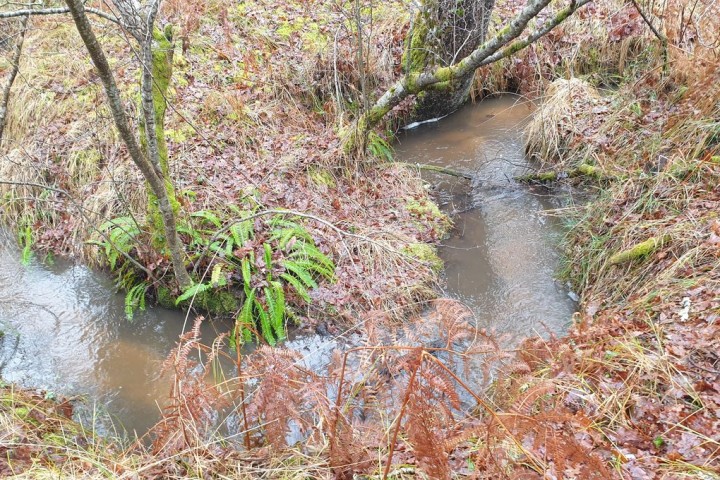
176;207;335;345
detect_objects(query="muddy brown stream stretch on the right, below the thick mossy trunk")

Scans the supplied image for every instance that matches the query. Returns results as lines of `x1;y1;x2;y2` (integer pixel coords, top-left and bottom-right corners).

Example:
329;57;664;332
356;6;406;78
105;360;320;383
396;95;575;342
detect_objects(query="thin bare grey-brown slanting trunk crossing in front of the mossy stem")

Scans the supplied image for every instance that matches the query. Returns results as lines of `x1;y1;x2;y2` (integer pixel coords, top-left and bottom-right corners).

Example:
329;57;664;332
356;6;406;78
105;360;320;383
65;0;193;290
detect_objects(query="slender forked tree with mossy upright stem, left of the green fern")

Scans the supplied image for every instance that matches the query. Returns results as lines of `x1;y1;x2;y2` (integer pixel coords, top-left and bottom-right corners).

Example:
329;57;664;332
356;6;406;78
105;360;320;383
0;0;193;290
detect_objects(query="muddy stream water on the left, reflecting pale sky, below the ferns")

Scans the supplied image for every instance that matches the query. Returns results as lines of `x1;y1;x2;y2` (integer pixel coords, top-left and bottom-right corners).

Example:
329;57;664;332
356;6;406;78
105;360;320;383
0;238;224;433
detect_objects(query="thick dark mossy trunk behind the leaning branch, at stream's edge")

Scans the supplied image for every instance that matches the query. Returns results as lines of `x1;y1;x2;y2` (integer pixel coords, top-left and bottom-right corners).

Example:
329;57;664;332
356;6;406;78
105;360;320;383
403;0;495;121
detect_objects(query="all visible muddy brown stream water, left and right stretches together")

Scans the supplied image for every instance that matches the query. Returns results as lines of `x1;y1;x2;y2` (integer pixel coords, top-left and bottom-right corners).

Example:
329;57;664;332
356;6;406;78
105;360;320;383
0;97;574;434
